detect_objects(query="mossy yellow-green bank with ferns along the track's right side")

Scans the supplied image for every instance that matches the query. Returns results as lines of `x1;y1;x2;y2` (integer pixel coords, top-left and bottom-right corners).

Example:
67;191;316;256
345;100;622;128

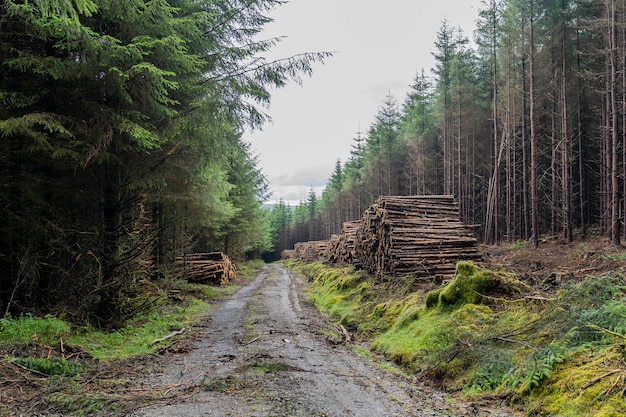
289;262;626;417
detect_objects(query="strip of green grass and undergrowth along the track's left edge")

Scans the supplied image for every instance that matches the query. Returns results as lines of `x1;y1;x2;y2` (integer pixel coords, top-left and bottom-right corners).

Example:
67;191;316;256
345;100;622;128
0;264;251;416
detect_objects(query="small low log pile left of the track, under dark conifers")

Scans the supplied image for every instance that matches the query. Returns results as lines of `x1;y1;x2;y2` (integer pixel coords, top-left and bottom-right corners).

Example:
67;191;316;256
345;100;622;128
175;252;237;285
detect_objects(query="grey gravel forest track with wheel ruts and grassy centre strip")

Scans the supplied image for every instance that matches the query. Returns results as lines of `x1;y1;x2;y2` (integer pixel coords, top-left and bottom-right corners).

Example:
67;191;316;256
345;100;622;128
133;264;514;417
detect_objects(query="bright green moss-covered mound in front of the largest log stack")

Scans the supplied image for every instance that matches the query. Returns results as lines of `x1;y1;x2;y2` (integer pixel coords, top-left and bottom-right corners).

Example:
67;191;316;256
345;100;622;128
426;261;532;309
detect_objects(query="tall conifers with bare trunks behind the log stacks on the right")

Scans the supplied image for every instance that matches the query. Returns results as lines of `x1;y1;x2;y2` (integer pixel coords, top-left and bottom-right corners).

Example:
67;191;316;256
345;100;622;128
273;0;626;251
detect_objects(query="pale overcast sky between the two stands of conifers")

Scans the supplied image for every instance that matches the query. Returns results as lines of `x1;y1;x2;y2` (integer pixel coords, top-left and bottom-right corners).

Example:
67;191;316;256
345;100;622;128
244;0;482;206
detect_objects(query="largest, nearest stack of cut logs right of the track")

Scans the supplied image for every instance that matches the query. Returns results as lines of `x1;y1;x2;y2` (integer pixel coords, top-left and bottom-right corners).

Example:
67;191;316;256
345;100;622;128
355;195;481;279
